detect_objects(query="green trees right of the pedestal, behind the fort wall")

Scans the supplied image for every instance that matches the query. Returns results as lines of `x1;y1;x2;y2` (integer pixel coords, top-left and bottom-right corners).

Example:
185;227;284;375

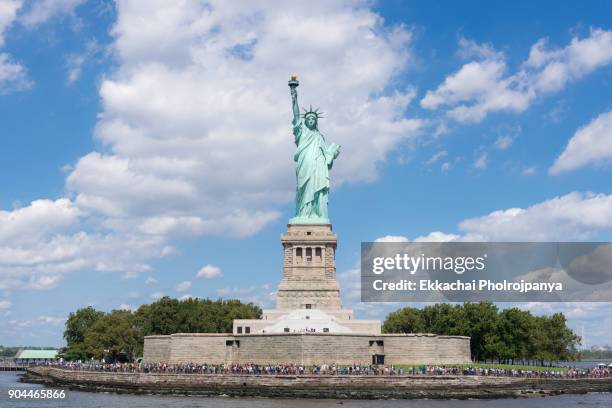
382;302;580;365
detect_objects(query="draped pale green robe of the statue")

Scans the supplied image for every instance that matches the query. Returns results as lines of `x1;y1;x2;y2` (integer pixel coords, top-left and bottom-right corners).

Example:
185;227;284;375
293;120;339;218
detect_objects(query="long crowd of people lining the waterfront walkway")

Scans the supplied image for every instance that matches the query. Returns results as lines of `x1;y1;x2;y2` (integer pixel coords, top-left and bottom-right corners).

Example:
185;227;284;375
39;361;612;378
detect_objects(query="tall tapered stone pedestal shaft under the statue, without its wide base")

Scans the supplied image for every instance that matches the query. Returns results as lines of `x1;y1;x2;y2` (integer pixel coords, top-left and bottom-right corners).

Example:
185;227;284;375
277;224;342;310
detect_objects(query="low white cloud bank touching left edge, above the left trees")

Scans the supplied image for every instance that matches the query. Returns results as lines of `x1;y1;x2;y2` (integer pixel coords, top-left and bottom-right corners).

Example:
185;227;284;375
0;199;167;289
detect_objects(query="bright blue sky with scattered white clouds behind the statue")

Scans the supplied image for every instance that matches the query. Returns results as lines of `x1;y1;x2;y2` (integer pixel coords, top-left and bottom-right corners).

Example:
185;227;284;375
0;0;612;346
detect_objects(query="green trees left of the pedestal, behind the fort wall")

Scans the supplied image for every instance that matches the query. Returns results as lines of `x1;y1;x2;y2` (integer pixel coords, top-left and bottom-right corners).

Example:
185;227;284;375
60;297;261;362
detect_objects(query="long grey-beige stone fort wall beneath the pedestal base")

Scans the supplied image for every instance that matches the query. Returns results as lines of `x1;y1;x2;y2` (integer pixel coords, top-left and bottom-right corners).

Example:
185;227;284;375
143;333;471;366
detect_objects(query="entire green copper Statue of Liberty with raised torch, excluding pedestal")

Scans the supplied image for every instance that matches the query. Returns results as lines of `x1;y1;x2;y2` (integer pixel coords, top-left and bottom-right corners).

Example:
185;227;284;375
289;76;340;224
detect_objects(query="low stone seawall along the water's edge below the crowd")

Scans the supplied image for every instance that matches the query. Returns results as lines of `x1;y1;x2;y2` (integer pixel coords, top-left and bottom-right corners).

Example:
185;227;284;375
24;367;612;399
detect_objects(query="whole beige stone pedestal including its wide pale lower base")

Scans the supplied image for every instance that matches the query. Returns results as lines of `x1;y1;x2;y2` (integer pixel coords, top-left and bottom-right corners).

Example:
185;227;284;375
233;224;380;335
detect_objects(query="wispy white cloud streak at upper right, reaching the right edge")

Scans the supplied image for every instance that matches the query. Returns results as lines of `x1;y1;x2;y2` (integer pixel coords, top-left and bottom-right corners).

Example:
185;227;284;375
421;29;612;122
